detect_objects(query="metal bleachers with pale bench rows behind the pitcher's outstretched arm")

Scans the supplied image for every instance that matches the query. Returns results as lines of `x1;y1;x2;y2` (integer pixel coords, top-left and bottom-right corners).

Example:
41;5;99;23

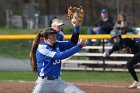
62;46;137;71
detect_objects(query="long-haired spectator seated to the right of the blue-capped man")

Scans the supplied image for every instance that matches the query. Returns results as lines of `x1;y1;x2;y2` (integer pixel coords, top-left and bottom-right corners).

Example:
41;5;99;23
114;12;133;34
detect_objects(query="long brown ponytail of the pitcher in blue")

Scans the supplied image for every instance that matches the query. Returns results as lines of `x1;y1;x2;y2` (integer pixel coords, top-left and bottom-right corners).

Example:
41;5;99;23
29;28;56;72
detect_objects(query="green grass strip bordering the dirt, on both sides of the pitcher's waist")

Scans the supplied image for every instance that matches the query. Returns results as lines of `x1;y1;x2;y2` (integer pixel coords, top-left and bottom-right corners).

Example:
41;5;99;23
0;71;140;82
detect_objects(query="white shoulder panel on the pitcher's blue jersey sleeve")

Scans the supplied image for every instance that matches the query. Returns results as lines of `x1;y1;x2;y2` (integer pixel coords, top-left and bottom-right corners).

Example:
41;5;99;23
38;45;56;58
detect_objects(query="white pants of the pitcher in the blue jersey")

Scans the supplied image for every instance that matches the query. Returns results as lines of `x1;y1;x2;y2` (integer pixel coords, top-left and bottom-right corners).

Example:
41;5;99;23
32;77;86;93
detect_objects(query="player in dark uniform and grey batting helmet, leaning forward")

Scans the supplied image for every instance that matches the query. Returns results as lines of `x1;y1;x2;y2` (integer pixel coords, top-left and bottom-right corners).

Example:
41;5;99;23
103;29;140;88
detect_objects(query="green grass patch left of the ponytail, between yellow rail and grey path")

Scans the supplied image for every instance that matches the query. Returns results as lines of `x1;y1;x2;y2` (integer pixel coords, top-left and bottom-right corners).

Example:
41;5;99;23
0;40;31;59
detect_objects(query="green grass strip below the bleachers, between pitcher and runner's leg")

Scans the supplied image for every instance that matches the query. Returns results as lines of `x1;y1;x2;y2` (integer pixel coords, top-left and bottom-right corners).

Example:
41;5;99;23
62;71;133;81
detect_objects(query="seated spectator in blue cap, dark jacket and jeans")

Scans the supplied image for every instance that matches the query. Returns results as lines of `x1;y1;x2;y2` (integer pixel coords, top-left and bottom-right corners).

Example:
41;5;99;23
87;9;114;45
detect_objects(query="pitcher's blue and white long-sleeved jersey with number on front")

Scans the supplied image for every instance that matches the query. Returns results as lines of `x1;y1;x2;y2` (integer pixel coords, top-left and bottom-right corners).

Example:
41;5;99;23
36;28;82;77
